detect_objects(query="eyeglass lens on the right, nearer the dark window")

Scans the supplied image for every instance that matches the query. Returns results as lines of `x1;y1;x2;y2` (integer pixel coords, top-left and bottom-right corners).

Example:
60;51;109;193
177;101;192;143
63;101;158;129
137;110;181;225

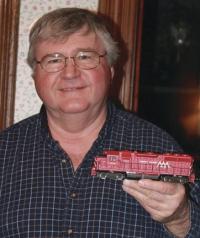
74;51;99;69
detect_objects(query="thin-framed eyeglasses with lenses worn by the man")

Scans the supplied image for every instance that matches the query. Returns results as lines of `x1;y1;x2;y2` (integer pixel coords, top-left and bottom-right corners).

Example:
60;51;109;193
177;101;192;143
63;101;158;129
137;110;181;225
36;51;106;73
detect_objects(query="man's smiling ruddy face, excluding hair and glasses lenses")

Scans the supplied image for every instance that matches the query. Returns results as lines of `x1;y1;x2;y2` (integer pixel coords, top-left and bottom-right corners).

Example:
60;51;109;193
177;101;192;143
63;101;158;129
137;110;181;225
33;29;113;116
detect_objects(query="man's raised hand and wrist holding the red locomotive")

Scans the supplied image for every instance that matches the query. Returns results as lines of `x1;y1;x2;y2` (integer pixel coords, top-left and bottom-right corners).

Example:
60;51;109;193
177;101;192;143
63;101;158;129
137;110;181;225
122;179;190;238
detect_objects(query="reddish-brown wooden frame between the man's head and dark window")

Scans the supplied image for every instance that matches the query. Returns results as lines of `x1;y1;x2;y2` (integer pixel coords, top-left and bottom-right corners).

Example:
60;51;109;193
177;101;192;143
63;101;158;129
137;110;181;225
98;0;144;111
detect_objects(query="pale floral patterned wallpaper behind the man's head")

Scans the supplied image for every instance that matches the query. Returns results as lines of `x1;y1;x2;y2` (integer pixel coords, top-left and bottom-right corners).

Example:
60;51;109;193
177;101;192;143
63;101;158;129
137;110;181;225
14;0;98;122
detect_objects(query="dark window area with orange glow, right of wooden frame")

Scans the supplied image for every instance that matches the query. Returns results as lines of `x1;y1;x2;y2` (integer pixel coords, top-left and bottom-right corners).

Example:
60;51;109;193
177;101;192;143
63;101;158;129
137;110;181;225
138;0;200;160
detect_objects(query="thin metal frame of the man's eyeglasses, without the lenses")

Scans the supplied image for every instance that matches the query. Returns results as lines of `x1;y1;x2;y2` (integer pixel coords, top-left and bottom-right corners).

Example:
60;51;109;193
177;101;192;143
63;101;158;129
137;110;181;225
35;50;107;73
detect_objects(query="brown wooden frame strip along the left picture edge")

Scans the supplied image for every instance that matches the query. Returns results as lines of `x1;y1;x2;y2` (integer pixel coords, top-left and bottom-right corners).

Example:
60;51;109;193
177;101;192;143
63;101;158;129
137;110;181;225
0;0;20;130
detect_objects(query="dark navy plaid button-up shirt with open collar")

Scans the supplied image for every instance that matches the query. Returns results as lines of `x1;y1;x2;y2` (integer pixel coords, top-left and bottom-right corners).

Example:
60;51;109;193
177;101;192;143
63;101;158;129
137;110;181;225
0;101;200;238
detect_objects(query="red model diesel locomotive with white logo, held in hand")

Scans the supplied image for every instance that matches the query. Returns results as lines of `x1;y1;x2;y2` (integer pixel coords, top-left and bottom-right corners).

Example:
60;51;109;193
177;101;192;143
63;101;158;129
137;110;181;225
91;150;195;183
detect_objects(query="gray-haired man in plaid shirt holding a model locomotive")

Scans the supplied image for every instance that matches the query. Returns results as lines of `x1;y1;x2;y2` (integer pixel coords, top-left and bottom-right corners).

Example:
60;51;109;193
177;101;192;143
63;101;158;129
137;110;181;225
0;8;200;238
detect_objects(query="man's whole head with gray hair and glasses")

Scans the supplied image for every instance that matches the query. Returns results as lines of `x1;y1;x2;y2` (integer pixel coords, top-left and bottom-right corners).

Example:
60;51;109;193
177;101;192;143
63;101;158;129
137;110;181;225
28;8;118;117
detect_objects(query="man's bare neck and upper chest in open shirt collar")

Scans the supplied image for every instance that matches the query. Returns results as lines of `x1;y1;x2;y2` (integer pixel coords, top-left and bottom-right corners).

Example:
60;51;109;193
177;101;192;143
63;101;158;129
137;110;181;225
47;105;107;170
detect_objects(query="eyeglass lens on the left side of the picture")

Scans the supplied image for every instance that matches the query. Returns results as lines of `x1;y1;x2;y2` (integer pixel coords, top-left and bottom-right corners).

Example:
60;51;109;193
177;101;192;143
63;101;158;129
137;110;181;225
41;54;65;73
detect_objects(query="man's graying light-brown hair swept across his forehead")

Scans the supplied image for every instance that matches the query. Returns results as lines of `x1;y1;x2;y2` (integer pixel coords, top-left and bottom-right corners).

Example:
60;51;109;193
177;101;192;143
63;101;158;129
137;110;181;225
27;8;119;68
